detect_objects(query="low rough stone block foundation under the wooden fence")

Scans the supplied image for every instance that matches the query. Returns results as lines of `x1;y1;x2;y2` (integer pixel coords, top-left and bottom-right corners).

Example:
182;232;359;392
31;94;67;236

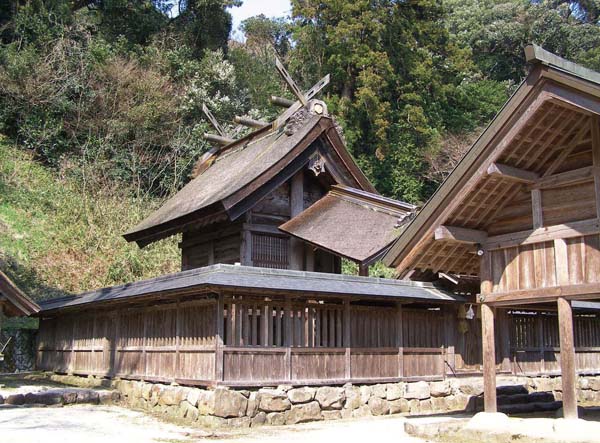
51;375;600;428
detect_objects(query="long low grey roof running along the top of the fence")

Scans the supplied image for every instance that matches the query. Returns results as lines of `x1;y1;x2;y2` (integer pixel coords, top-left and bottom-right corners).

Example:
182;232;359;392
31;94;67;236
41;264;463;312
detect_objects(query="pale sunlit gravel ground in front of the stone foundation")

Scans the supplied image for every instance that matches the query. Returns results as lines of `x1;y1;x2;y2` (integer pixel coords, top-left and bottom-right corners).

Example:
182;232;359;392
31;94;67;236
0;405;432;443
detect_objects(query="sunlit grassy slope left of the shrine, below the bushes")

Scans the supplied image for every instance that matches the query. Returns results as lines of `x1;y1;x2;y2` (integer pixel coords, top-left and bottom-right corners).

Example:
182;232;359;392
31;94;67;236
0;138;179;300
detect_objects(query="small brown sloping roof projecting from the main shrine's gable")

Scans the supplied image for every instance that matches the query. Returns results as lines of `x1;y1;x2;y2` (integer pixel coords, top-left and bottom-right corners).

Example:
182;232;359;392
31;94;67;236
279;186;416;263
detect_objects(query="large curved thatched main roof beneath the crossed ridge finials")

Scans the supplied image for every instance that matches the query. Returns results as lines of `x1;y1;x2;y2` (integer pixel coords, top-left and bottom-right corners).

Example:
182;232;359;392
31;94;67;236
124;108;374;246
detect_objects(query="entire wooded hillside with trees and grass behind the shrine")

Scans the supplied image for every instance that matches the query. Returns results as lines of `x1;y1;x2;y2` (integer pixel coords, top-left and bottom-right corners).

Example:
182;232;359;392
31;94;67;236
0;0;600;299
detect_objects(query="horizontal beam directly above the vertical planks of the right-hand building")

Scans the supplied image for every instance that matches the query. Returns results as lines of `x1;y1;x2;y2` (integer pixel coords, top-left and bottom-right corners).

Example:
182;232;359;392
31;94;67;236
484;218;600;249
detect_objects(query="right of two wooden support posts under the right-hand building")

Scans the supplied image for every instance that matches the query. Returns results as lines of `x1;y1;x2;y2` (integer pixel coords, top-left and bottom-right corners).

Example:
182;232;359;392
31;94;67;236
557;297;577;418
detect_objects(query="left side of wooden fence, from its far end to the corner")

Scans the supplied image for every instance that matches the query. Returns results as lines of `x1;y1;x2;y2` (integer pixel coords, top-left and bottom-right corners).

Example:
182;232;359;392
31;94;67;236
37;300;215;381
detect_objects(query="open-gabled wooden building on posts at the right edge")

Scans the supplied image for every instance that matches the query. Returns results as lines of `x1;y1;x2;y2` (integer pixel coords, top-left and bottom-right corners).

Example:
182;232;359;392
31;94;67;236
385;46;600;417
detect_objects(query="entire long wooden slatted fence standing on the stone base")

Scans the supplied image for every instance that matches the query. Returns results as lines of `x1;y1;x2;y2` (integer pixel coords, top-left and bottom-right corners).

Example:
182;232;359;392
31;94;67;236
37;294;600;386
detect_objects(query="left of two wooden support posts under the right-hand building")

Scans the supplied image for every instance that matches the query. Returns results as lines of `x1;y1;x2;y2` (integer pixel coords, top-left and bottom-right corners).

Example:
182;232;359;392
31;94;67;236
479;251;498;412
